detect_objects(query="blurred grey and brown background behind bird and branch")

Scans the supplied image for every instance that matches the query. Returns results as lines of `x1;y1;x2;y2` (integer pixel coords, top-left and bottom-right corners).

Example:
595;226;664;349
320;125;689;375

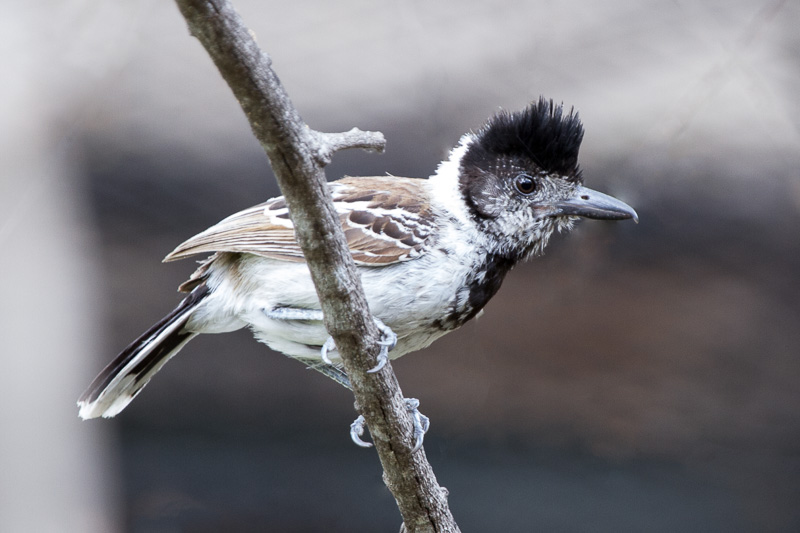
0;0;800;532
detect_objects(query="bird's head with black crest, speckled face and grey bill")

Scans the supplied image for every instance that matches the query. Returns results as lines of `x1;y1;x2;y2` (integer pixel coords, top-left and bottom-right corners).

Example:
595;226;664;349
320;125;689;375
453;98;638;259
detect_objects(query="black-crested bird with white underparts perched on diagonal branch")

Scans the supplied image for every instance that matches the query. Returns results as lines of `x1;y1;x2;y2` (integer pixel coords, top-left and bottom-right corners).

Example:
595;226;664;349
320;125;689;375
78;97;638;448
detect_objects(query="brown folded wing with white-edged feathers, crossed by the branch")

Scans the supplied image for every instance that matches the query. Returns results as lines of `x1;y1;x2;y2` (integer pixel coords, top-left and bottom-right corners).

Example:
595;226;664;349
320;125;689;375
164;176;433;266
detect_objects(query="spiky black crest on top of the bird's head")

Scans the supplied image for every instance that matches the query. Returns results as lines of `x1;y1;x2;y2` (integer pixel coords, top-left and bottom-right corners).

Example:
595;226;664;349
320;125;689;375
462;97;583;180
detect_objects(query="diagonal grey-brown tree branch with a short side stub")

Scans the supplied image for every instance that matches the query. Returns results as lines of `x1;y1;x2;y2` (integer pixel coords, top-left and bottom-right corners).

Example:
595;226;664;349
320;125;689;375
176;0;459;532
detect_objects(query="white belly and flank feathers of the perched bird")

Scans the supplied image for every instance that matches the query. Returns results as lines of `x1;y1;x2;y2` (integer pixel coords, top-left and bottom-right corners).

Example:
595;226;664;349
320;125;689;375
189;252;478;360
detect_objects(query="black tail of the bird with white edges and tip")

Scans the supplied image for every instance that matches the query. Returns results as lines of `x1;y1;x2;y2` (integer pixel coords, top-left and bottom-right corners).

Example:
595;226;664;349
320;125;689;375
78;284;208;420
